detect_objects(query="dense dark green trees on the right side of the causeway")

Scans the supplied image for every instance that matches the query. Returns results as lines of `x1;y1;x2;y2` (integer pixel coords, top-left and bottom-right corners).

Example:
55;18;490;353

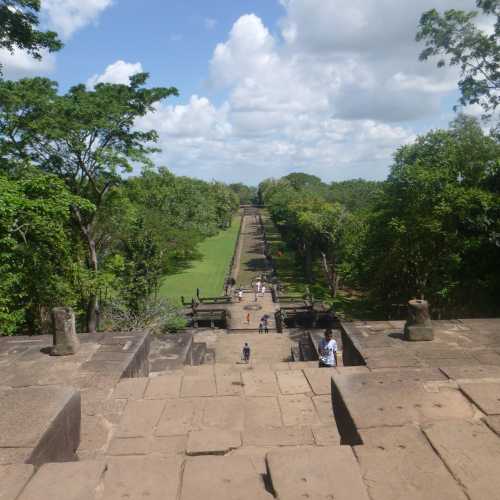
259;115;500;317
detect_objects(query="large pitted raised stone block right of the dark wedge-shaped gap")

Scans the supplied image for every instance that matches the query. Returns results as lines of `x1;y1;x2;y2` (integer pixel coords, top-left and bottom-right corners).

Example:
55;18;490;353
332;370;474;429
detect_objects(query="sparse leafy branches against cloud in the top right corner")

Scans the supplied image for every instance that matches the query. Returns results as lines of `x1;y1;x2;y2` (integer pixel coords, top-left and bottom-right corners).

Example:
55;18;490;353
417;0;500;116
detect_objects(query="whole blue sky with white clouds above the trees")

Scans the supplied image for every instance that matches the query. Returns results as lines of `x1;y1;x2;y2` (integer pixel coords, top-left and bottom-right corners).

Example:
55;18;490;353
0;0;484;185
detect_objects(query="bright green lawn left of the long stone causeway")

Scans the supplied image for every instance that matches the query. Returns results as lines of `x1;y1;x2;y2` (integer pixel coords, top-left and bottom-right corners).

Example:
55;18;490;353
160;216;240;304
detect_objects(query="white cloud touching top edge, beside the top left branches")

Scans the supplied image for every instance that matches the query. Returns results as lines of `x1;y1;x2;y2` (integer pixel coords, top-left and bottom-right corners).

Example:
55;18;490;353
42;0;112;39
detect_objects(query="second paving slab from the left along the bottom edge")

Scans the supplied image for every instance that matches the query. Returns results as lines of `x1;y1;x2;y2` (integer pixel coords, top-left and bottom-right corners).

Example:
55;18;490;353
19;460;106;500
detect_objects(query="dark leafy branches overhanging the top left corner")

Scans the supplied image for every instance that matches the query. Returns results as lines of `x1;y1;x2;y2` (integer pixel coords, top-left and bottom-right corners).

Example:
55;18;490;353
0;0;62;74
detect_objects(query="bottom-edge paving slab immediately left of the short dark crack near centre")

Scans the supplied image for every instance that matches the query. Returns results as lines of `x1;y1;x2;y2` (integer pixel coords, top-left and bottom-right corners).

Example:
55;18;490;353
180;455;273;500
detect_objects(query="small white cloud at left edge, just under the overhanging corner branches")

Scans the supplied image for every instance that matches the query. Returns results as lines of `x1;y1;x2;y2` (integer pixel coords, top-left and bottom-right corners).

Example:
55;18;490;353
0;49;55;80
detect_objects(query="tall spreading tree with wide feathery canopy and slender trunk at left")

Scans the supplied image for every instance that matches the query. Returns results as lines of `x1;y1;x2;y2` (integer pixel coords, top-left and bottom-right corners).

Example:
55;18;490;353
0;73;178;332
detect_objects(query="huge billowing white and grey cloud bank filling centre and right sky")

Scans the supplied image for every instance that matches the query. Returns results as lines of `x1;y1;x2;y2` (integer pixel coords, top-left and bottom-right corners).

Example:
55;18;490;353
135;0;474;183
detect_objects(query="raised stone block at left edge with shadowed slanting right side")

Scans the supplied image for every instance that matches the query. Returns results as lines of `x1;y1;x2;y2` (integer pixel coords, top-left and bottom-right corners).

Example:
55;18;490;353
0;386;81;465
